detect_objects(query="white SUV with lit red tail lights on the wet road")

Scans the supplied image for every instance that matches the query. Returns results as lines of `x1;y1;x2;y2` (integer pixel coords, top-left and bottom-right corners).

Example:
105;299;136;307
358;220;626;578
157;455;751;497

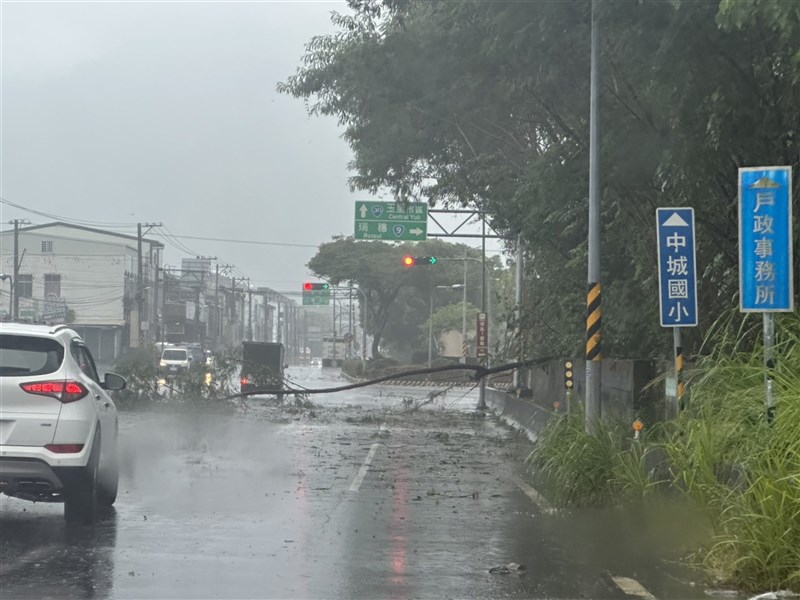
0;323;125;523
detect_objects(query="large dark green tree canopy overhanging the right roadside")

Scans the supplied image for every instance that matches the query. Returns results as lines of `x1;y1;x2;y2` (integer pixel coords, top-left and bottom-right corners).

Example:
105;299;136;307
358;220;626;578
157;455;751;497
279;0;800;356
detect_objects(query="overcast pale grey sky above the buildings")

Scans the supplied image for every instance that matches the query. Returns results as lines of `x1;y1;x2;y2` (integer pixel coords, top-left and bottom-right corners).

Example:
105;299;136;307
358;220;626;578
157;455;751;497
0;1;500;290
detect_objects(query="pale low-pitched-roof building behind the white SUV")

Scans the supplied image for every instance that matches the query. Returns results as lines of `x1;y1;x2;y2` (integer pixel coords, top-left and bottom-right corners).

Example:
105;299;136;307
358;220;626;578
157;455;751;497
0;222;164;363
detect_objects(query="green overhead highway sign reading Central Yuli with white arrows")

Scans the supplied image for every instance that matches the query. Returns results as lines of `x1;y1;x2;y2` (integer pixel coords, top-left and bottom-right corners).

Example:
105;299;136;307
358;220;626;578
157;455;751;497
355;202;428;242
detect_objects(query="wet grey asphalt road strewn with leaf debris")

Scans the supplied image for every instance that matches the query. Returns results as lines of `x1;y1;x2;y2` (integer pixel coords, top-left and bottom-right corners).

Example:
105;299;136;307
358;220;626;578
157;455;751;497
0;369;703;600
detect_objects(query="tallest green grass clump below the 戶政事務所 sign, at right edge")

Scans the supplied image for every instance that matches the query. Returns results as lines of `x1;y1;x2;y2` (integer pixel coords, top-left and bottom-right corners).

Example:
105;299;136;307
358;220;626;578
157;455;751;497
666;314;800;590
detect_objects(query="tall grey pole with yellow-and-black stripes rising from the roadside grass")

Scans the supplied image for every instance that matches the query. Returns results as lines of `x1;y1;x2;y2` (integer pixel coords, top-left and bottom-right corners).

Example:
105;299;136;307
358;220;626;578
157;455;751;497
586;0;603;433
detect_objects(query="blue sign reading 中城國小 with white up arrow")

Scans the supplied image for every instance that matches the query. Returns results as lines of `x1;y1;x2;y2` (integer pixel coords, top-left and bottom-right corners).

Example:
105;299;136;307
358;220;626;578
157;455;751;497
656;208;697;327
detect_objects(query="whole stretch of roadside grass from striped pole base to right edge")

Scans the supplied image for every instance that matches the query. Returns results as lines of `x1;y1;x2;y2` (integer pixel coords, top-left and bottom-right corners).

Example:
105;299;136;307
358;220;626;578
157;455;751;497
528;313;800;592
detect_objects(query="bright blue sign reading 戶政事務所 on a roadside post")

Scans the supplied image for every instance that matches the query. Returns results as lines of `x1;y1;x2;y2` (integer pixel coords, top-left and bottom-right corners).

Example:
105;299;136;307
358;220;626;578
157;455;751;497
739;167;794;312
